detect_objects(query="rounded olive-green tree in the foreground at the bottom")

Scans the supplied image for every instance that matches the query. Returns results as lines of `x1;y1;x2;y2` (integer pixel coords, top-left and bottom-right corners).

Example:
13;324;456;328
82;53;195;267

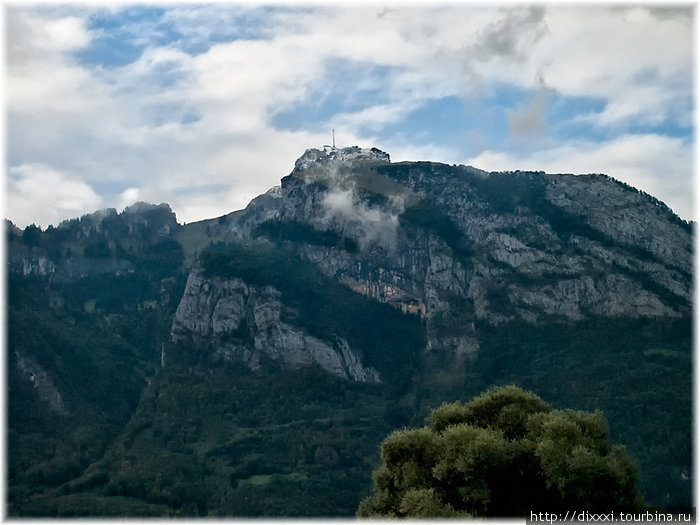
357;386;642;518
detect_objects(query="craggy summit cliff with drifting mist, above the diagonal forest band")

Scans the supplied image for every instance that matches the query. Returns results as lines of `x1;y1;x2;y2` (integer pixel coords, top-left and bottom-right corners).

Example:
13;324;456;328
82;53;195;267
268;148;478;354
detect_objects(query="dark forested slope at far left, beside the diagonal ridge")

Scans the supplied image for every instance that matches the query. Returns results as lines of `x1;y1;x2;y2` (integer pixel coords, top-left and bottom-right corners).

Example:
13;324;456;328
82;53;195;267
7;219;185;516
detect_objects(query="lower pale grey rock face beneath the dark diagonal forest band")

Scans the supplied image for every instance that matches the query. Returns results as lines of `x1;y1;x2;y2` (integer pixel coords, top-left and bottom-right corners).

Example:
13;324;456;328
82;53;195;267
172;267;381;383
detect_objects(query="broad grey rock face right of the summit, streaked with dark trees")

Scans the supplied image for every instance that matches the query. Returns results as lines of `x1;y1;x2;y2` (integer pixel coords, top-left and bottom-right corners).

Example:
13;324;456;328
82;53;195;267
378;165;692;319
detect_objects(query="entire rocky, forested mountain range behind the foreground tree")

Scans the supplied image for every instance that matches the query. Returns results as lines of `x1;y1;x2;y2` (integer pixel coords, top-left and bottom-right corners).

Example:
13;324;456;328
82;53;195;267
6;147;693;516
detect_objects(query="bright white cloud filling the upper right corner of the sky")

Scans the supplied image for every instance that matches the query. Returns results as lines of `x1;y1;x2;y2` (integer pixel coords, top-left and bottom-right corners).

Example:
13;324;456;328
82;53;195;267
530;6;693;126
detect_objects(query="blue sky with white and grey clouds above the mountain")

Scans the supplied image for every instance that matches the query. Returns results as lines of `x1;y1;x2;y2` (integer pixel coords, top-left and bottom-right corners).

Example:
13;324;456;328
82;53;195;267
5;2;696;227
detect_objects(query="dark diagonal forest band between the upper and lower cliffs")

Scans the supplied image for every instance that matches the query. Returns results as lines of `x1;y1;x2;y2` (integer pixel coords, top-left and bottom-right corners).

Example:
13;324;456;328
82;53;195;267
201;247;425;385
